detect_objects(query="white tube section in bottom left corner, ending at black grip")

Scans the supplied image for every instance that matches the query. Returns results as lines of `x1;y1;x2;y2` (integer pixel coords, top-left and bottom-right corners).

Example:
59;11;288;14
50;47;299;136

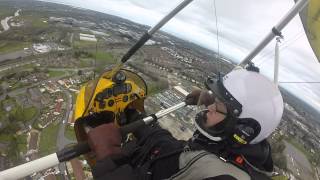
0;153;59;180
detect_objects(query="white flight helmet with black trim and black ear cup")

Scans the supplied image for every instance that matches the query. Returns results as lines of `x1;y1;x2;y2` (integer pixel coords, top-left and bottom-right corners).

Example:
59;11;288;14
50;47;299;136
196;69;283;145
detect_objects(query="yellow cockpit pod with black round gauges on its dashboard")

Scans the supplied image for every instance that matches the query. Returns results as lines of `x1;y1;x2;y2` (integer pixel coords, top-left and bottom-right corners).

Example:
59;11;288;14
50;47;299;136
73;69;147;166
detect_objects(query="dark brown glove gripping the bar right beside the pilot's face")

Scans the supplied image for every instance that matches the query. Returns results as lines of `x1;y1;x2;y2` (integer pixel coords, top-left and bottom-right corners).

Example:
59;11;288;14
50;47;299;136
185;89;214;106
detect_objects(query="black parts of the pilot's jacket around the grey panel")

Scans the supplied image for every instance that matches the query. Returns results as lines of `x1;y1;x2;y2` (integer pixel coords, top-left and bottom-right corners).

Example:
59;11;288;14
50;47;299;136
92;125;273;180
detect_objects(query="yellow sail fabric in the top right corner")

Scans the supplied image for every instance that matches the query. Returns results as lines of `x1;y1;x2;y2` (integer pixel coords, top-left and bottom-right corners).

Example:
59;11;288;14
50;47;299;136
300;0;320;62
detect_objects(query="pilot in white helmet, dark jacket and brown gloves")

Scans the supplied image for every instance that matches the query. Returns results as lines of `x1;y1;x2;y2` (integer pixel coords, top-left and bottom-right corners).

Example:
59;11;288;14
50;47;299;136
88;69;283;180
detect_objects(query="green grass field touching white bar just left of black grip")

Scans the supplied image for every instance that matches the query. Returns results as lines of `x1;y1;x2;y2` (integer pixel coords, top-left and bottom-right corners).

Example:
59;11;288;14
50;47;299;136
39;123;59;156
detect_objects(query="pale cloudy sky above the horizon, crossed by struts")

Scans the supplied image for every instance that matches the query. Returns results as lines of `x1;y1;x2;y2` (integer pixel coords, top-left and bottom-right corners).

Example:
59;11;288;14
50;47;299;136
43;0;320;109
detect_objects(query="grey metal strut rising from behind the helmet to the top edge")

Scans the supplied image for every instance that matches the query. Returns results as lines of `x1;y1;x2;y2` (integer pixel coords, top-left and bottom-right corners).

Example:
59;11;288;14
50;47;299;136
239;0;308;67
